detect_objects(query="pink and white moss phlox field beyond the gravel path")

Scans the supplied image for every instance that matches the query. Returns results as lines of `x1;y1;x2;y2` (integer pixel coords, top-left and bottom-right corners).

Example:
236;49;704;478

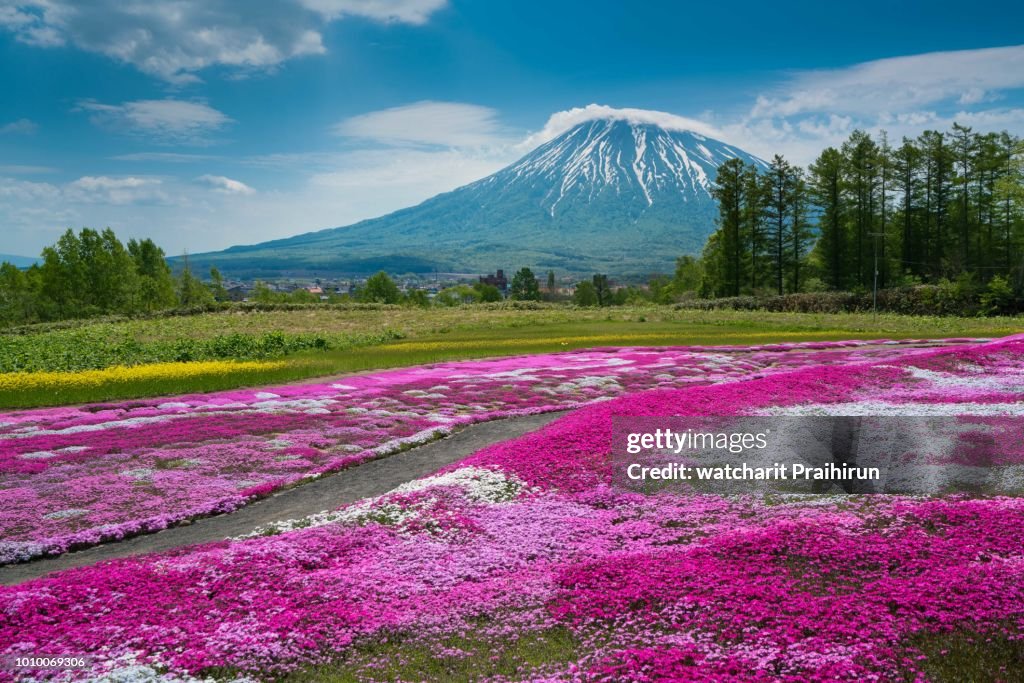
0;340;965;564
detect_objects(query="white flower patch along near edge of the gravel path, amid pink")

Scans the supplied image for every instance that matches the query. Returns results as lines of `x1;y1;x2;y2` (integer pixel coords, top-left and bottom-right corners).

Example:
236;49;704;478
236;467;529;540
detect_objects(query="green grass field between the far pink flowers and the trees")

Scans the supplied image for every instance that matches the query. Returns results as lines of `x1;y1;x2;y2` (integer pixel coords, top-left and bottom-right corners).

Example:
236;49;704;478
0;305;1024;409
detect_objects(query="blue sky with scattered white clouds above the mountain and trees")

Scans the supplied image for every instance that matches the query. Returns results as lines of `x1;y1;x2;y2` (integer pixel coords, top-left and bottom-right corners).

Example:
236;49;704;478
0;0;1024;255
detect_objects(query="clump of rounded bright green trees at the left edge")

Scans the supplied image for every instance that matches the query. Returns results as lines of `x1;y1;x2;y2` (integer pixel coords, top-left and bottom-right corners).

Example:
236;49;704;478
0;228;223;325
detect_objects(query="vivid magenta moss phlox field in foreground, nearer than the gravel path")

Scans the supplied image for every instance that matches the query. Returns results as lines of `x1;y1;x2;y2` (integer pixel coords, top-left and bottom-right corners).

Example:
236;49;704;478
0;337;1024;682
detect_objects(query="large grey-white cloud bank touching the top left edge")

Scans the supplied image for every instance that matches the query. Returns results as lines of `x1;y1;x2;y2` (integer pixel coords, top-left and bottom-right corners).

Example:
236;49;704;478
0;0;444;85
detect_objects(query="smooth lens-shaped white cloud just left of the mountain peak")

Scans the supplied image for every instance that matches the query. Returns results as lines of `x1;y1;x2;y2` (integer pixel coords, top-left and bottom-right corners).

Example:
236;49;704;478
333;101;511;147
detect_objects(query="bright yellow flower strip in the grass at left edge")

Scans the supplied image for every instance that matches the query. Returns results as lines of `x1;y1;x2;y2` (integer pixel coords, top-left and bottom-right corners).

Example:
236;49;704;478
0;360;287;391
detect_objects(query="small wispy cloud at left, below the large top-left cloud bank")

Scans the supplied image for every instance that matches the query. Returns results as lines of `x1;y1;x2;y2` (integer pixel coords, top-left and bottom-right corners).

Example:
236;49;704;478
77;98;231;144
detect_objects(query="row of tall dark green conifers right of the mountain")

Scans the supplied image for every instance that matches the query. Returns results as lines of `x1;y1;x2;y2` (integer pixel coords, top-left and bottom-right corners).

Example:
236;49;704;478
701;124;1024;297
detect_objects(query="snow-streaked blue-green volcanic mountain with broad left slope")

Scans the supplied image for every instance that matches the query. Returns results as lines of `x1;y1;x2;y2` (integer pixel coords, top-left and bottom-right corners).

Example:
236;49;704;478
189;117;764;276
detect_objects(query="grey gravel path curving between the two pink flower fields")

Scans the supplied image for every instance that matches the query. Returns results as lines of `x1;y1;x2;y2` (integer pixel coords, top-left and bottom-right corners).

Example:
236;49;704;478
0;411;565;586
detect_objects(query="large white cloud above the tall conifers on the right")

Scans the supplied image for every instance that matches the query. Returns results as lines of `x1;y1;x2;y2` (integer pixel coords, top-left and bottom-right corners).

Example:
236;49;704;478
708;45;1024;165
